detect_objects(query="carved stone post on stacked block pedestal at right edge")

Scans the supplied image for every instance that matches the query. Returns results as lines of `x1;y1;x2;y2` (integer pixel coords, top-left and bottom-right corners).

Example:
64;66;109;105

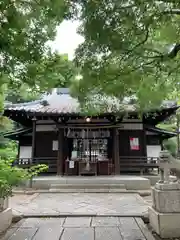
149;151;180;238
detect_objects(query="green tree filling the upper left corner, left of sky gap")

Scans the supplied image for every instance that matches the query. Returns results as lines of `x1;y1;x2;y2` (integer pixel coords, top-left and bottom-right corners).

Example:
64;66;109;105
0;0;68;108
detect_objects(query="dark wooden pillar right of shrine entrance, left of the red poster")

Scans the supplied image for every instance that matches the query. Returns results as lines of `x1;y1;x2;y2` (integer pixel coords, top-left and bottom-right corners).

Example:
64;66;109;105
113;128;120;175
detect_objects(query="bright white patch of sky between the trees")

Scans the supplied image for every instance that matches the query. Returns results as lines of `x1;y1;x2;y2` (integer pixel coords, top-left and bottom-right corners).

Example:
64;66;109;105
50;20;84;60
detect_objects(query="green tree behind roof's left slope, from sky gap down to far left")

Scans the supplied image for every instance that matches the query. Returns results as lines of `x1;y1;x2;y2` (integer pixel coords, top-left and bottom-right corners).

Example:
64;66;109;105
5;51;77;103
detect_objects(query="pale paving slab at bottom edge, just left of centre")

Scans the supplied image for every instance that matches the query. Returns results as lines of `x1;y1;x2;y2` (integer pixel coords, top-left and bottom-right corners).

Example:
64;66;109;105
61;228;94;240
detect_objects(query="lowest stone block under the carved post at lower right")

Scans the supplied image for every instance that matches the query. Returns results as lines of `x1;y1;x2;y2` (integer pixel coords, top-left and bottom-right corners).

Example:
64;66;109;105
148;207;180;238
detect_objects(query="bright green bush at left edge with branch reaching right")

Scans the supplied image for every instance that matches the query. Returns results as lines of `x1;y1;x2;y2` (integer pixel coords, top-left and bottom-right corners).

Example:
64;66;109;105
0;159;48;199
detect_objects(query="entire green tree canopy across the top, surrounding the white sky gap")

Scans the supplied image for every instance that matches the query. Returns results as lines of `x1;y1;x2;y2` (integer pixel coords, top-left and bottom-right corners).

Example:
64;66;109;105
0;0;180;111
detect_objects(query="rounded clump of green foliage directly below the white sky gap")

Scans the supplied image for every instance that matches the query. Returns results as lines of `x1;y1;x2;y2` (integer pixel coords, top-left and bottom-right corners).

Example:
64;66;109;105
25;52;77;91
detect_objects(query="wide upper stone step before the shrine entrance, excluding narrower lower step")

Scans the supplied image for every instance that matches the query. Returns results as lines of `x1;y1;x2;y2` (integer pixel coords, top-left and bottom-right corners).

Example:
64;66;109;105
32;175;150;191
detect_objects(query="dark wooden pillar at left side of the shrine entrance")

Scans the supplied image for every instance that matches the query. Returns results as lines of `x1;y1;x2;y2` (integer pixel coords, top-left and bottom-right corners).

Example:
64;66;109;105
57;129;64;176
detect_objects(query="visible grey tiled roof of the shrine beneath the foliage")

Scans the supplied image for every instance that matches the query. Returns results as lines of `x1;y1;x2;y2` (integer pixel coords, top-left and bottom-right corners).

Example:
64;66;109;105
5;88;175;114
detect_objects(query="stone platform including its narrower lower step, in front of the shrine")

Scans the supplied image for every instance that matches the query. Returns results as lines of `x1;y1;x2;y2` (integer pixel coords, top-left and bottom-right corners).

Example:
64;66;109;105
29;175;150;192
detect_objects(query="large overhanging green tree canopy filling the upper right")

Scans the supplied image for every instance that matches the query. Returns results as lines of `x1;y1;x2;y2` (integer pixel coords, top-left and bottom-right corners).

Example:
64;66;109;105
68;0;180;107
